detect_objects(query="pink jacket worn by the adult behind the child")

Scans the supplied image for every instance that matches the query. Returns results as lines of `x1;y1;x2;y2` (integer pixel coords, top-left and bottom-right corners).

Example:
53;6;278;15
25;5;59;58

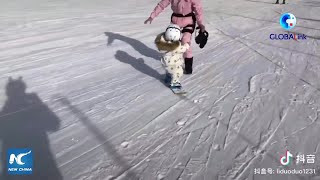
150;0;203;25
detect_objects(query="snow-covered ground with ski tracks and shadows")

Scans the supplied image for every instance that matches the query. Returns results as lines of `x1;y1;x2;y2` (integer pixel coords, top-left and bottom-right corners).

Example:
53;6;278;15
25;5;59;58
0;0;320;180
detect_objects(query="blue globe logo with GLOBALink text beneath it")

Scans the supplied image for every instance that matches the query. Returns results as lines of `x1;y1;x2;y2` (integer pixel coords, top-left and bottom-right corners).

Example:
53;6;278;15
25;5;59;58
270;13;307;41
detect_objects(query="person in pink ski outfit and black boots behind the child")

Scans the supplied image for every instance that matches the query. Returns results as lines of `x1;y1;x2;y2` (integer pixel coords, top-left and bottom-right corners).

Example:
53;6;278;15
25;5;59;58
144;0;205;74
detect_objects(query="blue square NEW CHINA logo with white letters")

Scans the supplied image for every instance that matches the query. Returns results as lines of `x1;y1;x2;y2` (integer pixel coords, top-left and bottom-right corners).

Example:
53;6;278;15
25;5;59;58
7;149;33;175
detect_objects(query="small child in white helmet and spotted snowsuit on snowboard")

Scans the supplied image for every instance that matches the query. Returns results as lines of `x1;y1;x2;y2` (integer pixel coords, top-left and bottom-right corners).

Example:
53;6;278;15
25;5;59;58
155;24;189;93
